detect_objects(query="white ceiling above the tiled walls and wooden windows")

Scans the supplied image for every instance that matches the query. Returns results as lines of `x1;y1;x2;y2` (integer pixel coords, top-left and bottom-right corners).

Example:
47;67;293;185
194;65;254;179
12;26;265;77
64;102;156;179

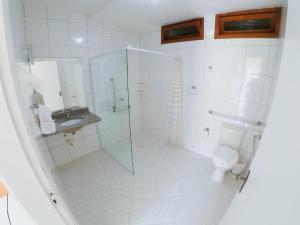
29;0;287;31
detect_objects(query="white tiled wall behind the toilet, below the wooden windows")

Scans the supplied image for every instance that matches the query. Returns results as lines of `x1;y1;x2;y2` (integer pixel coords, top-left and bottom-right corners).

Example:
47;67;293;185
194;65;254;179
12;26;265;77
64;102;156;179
141;15;282;158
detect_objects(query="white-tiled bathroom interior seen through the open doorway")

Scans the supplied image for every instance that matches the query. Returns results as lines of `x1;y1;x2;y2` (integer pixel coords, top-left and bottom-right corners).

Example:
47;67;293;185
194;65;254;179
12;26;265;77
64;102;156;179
7;0;287;225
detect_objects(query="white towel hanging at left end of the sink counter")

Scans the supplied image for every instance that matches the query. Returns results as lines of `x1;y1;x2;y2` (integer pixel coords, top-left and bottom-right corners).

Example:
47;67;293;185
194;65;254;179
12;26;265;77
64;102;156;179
37;105;56;134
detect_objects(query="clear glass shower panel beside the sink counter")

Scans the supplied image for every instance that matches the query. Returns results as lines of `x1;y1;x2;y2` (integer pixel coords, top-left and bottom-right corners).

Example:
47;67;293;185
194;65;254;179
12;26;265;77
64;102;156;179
91;50;134;173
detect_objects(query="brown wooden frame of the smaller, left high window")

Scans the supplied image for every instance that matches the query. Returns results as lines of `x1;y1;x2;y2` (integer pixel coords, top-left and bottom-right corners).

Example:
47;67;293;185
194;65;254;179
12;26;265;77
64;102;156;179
161;18;204;44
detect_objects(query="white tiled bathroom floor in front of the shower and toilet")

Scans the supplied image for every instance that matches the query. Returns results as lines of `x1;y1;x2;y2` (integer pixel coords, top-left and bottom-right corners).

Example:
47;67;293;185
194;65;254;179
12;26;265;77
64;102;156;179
57;135;239;225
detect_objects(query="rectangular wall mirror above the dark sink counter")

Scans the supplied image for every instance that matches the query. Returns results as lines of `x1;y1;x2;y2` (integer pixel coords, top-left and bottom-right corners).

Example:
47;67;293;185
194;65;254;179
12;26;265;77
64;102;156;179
31;58;87;111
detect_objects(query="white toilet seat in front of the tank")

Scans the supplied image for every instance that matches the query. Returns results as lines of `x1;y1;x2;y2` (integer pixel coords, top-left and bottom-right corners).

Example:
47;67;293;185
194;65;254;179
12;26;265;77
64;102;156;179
213;146;239;168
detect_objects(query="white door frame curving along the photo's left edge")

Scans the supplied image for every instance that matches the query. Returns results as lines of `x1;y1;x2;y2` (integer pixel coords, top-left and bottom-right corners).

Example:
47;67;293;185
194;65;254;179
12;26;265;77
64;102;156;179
0;1;70;224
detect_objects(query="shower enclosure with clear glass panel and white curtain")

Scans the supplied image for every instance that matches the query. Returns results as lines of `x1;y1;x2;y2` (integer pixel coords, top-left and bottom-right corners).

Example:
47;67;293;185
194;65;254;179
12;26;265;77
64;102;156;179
91;48;183;174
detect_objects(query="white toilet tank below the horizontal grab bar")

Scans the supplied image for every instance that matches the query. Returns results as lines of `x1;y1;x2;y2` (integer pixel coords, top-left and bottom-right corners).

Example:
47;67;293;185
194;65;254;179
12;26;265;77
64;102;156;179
219;123;246;150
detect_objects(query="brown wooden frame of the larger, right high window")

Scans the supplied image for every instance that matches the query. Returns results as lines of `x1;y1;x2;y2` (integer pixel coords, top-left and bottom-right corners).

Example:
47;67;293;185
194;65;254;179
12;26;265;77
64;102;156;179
215;7;282;39
